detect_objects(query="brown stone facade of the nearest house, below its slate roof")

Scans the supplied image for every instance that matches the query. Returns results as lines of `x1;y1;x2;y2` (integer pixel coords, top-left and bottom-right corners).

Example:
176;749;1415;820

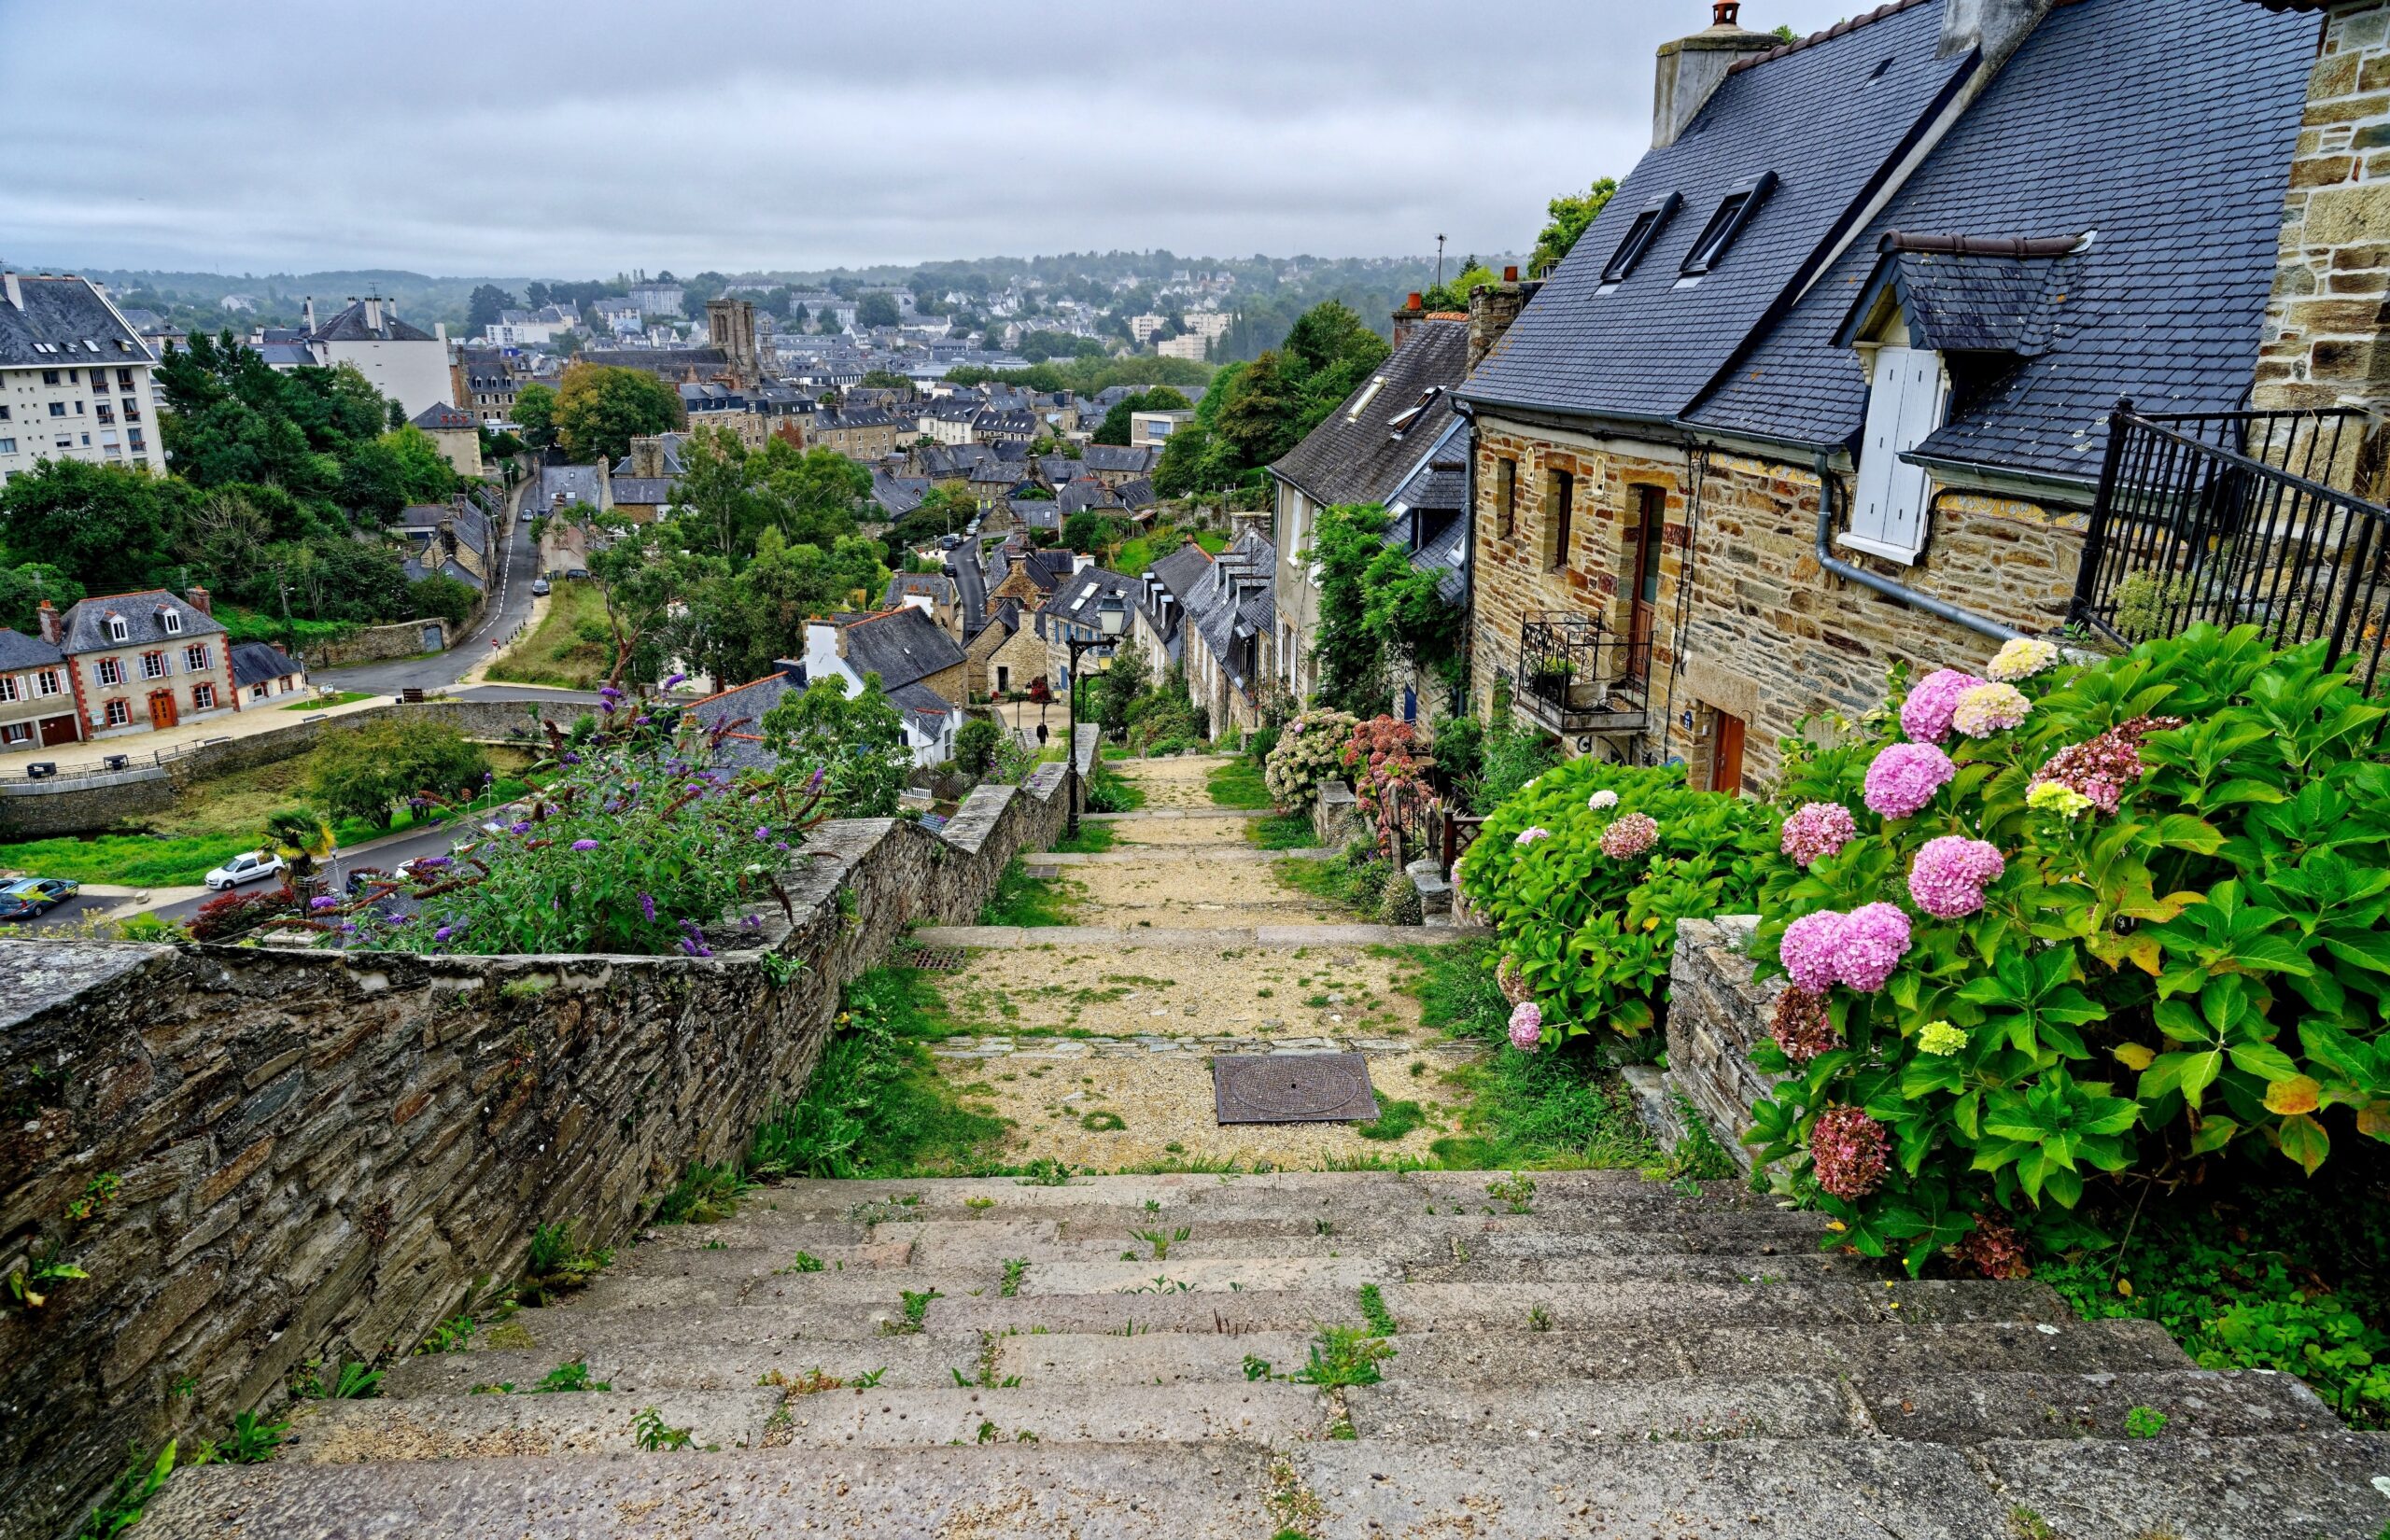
1472;418;2084;788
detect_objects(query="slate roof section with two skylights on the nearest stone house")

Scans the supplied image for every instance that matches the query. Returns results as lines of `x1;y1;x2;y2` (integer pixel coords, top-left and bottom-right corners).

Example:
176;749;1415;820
1460;0;1969;420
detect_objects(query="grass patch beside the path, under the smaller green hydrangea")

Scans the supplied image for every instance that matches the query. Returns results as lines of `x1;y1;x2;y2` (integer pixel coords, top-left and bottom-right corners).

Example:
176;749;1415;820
1385;935;1659;1169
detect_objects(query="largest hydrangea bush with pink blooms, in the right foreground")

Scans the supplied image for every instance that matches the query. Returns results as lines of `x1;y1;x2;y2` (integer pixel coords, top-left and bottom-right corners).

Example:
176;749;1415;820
1750;628;2390;1270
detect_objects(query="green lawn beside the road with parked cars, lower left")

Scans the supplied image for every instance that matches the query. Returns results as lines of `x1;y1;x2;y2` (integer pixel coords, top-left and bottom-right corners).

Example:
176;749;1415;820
0;748;530;889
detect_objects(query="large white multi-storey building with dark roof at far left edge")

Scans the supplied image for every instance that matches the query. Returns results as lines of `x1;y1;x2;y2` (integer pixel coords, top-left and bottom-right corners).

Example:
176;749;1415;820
0;273;168;486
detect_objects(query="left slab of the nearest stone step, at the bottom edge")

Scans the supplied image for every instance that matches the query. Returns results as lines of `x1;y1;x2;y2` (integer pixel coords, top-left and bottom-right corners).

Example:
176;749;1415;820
141;1445;1276;1540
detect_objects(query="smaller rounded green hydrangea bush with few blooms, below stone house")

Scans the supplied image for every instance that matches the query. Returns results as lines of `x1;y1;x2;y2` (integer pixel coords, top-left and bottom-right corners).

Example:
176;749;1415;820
1458;759;1778;1041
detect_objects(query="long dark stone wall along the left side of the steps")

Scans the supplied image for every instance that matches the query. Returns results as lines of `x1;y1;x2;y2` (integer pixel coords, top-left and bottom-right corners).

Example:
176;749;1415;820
0;728;1092;1540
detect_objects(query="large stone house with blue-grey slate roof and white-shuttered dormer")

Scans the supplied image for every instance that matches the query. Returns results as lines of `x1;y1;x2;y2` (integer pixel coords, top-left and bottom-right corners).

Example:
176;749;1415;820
1458;0;2323;788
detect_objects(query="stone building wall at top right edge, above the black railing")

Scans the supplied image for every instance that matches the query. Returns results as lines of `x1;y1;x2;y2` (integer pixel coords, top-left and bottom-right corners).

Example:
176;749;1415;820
2256;0;2390;411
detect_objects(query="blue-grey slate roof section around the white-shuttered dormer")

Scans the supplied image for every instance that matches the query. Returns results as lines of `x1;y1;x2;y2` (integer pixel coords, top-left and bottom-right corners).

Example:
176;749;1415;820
1692;0;2316;483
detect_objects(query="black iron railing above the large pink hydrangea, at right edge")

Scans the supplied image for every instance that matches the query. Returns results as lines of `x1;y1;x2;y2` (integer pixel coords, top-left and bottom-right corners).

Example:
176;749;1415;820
2070;401;2390;690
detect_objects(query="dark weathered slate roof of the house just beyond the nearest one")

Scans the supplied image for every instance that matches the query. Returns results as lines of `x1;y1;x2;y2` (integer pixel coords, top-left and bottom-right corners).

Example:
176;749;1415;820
1269;320;1469;504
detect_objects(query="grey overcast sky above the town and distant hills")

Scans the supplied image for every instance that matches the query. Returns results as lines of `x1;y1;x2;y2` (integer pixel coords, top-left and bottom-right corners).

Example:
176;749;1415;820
0;0;1866;277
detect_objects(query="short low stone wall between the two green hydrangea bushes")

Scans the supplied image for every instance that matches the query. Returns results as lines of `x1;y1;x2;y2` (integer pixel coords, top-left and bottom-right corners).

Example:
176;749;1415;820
1642;915;1785;1169
